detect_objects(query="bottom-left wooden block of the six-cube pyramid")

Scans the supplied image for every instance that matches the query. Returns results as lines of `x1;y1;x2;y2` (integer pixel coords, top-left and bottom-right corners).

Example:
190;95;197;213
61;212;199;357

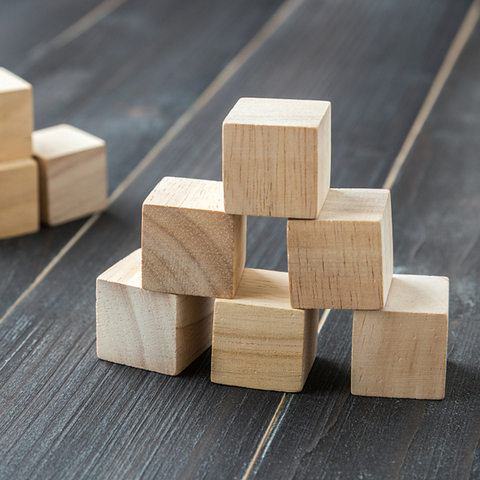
97;249;214;375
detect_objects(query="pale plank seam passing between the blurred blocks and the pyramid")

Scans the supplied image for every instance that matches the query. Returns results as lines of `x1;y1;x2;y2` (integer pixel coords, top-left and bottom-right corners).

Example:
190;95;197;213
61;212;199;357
0;0;304;323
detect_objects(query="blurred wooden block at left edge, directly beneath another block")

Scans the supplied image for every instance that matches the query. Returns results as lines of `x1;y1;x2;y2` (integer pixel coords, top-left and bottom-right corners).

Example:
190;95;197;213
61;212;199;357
0;158;40;238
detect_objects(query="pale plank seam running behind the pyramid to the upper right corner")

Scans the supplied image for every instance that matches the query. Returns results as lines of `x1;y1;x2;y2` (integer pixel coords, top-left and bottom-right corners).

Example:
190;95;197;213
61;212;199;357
242;0;480;480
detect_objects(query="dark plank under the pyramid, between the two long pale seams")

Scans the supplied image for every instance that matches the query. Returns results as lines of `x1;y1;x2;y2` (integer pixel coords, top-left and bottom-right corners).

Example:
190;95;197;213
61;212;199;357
0;0;468;478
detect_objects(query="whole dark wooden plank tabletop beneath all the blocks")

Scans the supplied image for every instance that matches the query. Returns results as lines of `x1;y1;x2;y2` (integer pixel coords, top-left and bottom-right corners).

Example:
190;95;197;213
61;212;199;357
0;0;480;479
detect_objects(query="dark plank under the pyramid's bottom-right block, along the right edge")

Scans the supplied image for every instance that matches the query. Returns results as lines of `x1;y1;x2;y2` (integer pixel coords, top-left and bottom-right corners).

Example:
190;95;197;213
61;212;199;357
250;9;480;479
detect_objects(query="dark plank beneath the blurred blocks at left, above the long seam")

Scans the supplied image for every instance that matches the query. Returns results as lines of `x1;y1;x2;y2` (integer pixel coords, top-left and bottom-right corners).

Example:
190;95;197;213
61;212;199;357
0;0;282;317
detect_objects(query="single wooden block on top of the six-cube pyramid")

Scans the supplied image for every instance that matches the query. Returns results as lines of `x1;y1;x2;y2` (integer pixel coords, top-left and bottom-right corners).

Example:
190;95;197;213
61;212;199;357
223;98;331;218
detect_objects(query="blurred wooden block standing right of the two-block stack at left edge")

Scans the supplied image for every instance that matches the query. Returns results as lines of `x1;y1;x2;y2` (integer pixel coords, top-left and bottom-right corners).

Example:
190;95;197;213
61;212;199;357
32;125;107;225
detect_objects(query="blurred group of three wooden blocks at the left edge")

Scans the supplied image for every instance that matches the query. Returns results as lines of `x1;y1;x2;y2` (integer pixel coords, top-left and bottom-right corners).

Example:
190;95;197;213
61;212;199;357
0;68;107;239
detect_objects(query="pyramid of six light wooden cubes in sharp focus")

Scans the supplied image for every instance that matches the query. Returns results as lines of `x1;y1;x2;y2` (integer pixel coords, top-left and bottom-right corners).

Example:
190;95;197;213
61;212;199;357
97;98;448;399
